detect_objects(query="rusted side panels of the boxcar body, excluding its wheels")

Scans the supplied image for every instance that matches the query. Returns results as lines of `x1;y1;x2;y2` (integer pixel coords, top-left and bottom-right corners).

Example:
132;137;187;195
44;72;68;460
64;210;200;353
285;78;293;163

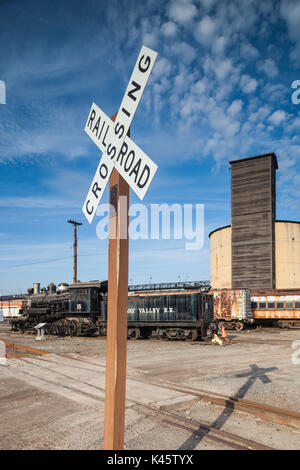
211;289;252;321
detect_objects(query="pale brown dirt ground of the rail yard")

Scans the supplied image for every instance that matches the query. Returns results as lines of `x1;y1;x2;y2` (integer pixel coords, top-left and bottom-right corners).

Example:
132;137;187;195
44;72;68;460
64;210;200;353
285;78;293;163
0;323;300;450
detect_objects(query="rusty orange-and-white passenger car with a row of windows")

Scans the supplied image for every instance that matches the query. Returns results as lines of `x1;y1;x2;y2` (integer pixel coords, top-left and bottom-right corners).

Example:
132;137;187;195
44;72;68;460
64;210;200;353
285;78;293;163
251;289;300;328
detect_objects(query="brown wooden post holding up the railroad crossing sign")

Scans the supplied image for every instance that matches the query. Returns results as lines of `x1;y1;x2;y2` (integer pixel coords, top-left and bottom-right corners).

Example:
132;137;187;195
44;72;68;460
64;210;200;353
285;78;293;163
104;115;129;450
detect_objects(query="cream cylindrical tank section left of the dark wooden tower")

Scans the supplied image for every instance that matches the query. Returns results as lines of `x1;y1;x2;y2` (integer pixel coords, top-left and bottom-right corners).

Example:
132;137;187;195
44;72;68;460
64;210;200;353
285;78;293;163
209;225;231;289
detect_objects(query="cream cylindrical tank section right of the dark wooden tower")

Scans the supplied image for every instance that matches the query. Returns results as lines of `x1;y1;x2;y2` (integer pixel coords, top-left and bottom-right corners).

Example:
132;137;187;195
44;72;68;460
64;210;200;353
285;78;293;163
275;220;300;289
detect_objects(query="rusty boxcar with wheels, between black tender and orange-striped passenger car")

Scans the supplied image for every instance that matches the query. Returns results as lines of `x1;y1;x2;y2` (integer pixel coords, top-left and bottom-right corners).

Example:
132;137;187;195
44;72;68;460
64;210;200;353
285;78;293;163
210;288;253;330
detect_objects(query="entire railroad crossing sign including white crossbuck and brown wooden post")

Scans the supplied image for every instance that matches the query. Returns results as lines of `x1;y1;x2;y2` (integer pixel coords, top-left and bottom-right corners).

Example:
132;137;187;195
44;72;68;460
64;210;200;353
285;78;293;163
82;46;157;450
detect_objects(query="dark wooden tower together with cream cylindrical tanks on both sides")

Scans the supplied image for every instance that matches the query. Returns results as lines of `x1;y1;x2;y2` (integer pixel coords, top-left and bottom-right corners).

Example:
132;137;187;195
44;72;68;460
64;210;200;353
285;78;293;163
209;153;300;289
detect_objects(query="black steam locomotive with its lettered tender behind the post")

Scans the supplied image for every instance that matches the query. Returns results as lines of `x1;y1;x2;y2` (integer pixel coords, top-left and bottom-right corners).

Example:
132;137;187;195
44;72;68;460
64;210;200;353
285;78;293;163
11;281;217;340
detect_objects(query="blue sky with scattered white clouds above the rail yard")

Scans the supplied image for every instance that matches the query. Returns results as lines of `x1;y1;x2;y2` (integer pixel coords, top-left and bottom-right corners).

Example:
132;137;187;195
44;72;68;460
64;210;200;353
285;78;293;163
0;0;300;294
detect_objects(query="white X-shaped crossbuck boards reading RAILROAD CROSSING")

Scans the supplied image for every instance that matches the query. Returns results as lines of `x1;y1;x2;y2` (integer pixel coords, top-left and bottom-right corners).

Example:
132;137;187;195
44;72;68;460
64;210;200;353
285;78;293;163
82;46;157;223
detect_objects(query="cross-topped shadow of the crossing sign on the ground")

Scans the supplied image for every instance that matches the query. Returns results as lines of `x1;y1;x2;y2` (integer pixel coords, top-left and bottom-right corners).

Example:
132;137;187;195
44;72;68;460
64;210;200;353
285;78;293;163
179;364;277;450
